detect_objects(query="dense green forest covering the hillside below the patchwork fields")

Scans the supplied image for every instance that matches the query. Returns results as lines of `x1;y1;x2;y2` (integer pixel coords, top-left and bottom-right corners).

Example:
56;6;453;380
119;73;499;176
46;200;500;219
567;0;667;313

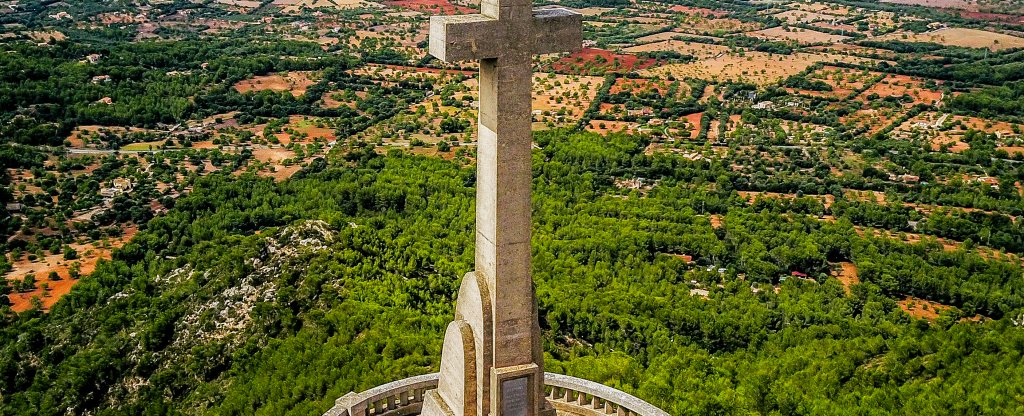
0;131;1024;415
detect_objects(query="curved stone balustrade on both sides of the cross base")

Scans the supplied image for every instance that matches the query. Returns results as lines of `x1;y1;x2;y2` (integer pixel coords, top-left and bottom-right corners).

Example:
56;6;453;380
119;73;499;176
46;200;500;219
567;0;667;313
324;373;669;416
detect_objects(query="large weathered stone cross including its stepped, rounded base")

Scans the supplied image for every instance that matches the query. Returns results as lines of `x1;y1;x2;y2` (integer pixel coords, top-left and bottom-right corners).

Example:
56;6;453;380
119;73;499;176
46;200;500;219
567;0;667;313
423;0;583;416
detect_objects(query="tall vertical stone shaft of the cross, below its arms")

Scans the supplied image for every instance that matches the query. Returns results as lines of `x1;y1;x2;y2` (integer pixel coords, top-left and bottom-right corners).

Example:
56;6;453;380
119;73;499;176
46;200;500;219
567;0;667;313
476;54;534;367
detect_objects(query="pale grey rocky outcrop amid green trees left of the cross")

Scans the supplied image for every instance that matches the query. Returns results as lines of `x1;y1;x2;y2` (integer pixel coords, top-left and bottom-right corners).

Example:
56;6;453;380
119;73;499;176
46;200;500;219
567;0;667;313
98;221;336;414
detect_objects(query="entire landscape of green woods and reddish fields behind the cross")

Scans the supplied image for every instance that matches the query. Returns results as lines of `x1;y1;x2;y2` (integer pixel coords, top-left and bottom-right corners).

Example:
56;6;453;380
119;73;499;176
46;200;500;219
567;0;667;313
6;0;1024;416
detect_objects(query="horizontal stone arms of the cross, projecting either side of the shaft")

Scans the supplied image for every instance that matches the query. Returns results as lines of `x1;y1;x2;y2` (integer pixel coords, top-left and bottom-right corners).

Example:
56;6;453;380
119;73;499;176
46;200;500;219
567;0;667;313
430;8;583;63
